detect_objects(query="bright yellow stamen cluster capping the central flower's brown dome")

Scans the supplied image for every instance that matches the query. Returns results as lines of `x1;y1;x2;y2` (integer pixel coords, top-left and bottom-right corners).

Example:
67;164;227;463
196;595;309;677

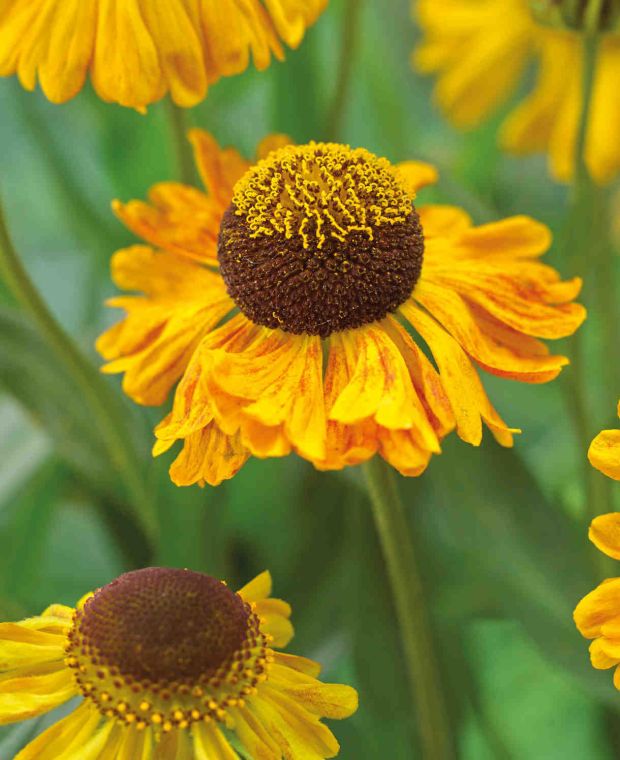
232;143;411;250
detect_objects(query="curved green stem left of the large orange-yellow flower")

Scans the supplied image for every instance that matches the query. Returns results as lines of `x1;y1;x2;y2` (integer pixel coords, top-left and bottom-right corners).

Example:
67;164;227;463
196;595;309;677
0;199;157;541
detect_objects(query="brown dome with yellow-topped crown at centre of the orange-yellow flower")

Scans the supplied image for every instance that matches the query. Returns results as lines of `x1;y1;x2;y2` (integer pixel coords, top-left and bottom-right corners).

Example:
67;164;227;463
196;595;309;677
218;143;424;337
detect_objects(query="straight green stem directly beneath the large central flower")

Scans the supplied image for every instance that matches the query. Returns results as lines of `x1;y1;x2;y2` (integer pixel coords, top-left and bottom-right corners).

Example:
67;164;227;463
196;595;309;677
363;457;455;760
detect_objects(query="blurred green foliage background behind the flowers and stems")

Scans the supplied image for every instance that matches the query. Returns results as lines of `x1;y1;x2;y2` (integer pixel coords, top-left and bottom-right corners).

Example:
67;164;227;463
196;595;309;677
0;0;620;760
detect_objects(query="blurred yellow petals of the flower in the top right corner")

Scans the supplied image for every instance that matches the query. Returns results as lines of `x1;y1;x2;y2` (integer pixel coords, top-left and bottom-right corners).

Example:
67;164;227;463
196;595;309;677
413;0;620;182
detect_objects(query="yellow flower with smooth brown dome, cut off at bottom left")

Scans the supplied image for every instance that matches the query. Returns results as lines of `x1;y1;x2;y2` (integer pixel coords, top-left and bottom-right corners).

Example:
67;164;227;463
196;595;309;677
0;568;357;760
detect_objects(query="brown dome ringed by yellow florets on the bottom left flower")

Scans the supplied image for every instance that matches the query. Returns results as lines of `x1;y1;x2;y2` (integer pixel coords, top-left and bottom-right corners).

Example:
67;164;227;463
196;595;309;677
67;568;270;731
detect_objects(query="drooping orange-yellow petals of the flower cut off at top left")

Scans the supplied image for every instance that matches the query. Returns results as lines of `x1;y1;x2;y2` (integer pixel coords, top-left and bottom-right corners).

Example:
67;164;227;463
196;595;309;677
0;0;328;110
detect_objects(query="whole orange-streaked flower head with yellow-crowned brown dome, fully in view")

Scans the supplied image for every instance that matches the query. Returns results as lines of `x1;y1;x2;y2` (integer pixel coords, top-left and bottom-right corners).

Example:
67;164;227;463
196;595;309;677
98;132;584;485
